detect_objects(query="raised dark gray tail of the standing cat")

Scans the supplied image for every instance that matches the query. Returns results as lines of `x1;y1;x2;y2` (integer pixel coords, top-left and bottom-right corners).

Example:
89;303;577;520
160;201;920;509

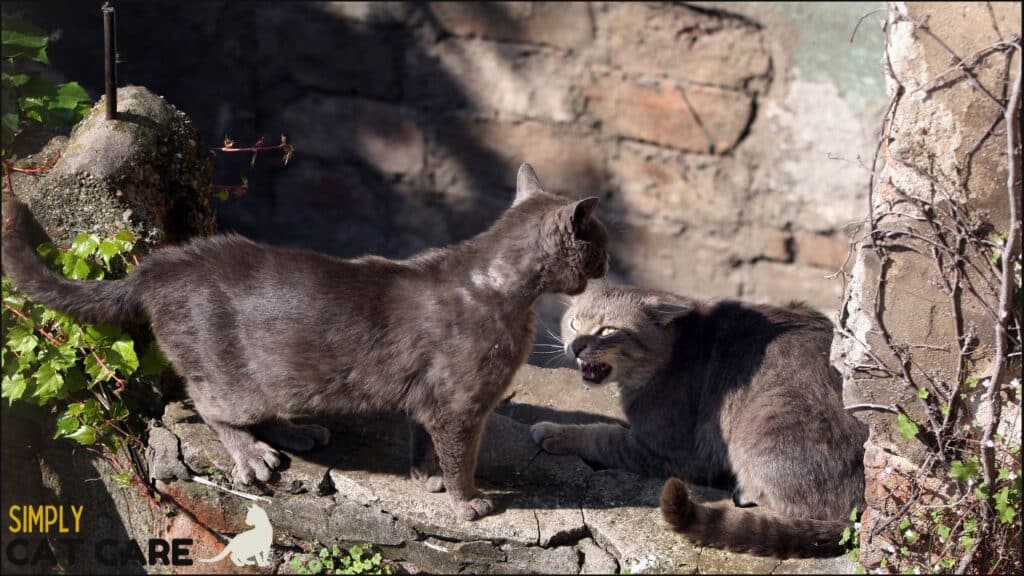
3;197;142;324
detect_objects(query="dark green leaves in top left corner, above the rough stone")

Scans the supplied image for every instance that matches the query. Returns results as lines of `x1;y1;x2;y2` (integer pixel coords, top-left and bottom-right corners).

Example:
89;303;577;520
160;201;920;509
0;13;92;151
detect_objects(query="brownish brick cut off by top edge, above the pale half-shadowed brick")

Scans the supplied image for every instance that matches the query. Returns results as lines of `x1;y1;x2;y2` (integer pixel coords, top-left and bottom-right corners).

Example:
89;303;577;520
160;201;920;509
429;2;594;48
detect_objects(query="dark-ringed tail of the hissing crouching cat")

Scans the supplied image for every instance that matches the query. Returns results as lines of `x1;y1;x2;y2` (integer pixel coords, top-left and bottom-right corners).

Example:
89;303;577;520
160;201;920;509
662;478;850;558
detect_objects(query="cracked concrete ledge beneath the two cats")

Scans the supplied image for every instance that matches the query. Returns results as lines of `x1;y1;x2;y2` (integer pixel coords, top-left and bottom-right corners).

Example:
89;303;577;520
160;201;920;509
149;366;852;574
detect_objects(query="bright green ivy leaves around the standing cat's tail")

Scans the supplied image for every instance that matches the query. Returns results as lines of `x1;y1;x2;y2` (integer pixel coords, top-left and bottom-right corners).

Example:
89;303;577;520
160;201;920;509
2;231;167;452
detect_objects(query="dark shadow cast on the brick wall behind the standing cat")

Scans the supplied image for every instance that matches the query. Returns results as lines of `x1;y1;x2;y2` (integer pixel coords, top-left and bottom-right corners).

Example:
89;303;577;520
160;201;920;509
5;0;599;257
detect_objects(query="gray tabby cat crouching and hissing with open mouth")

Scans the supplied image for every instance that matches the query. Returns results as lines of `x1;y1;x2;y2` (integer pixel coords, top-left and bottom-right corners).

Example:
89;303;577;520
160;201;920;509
530;283;867;557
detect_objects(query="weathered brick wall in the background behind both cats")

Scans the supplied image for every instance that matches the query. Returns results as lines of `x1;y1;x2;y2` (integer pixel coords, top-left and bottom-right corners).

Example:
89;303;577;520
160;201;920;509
12;2;884;314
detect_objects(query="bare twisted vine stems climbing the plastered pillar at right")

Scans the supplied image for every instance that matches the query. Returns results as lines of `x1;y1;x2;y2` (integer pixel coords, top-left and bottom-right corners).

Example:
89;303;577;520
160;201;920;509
837;6;1024;573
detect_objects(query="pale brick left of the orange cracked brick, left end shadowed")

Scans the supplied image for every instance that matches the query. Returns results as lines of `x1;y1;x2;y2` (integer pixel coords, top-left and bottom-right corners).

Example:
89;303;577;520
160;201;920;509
407;38;582;122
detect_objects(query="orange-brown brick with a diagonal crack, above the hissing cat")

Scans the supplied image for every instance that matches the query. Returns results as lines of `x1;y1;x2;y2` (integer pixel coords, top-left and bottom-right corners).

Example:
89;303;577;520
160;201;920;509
586;75;754;154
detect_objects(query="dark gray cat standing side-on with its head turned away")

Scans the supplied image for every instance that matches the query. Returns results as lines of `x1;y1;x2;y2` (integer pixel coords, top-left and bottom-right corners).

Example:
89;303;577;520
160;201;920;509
3;164;607;520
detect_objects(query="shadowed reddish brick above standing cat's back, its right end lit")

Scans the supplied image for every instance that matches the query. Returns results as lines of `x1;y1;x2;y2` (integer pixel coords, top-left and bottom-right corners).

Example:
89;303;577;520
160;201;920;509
281;95;424;174
